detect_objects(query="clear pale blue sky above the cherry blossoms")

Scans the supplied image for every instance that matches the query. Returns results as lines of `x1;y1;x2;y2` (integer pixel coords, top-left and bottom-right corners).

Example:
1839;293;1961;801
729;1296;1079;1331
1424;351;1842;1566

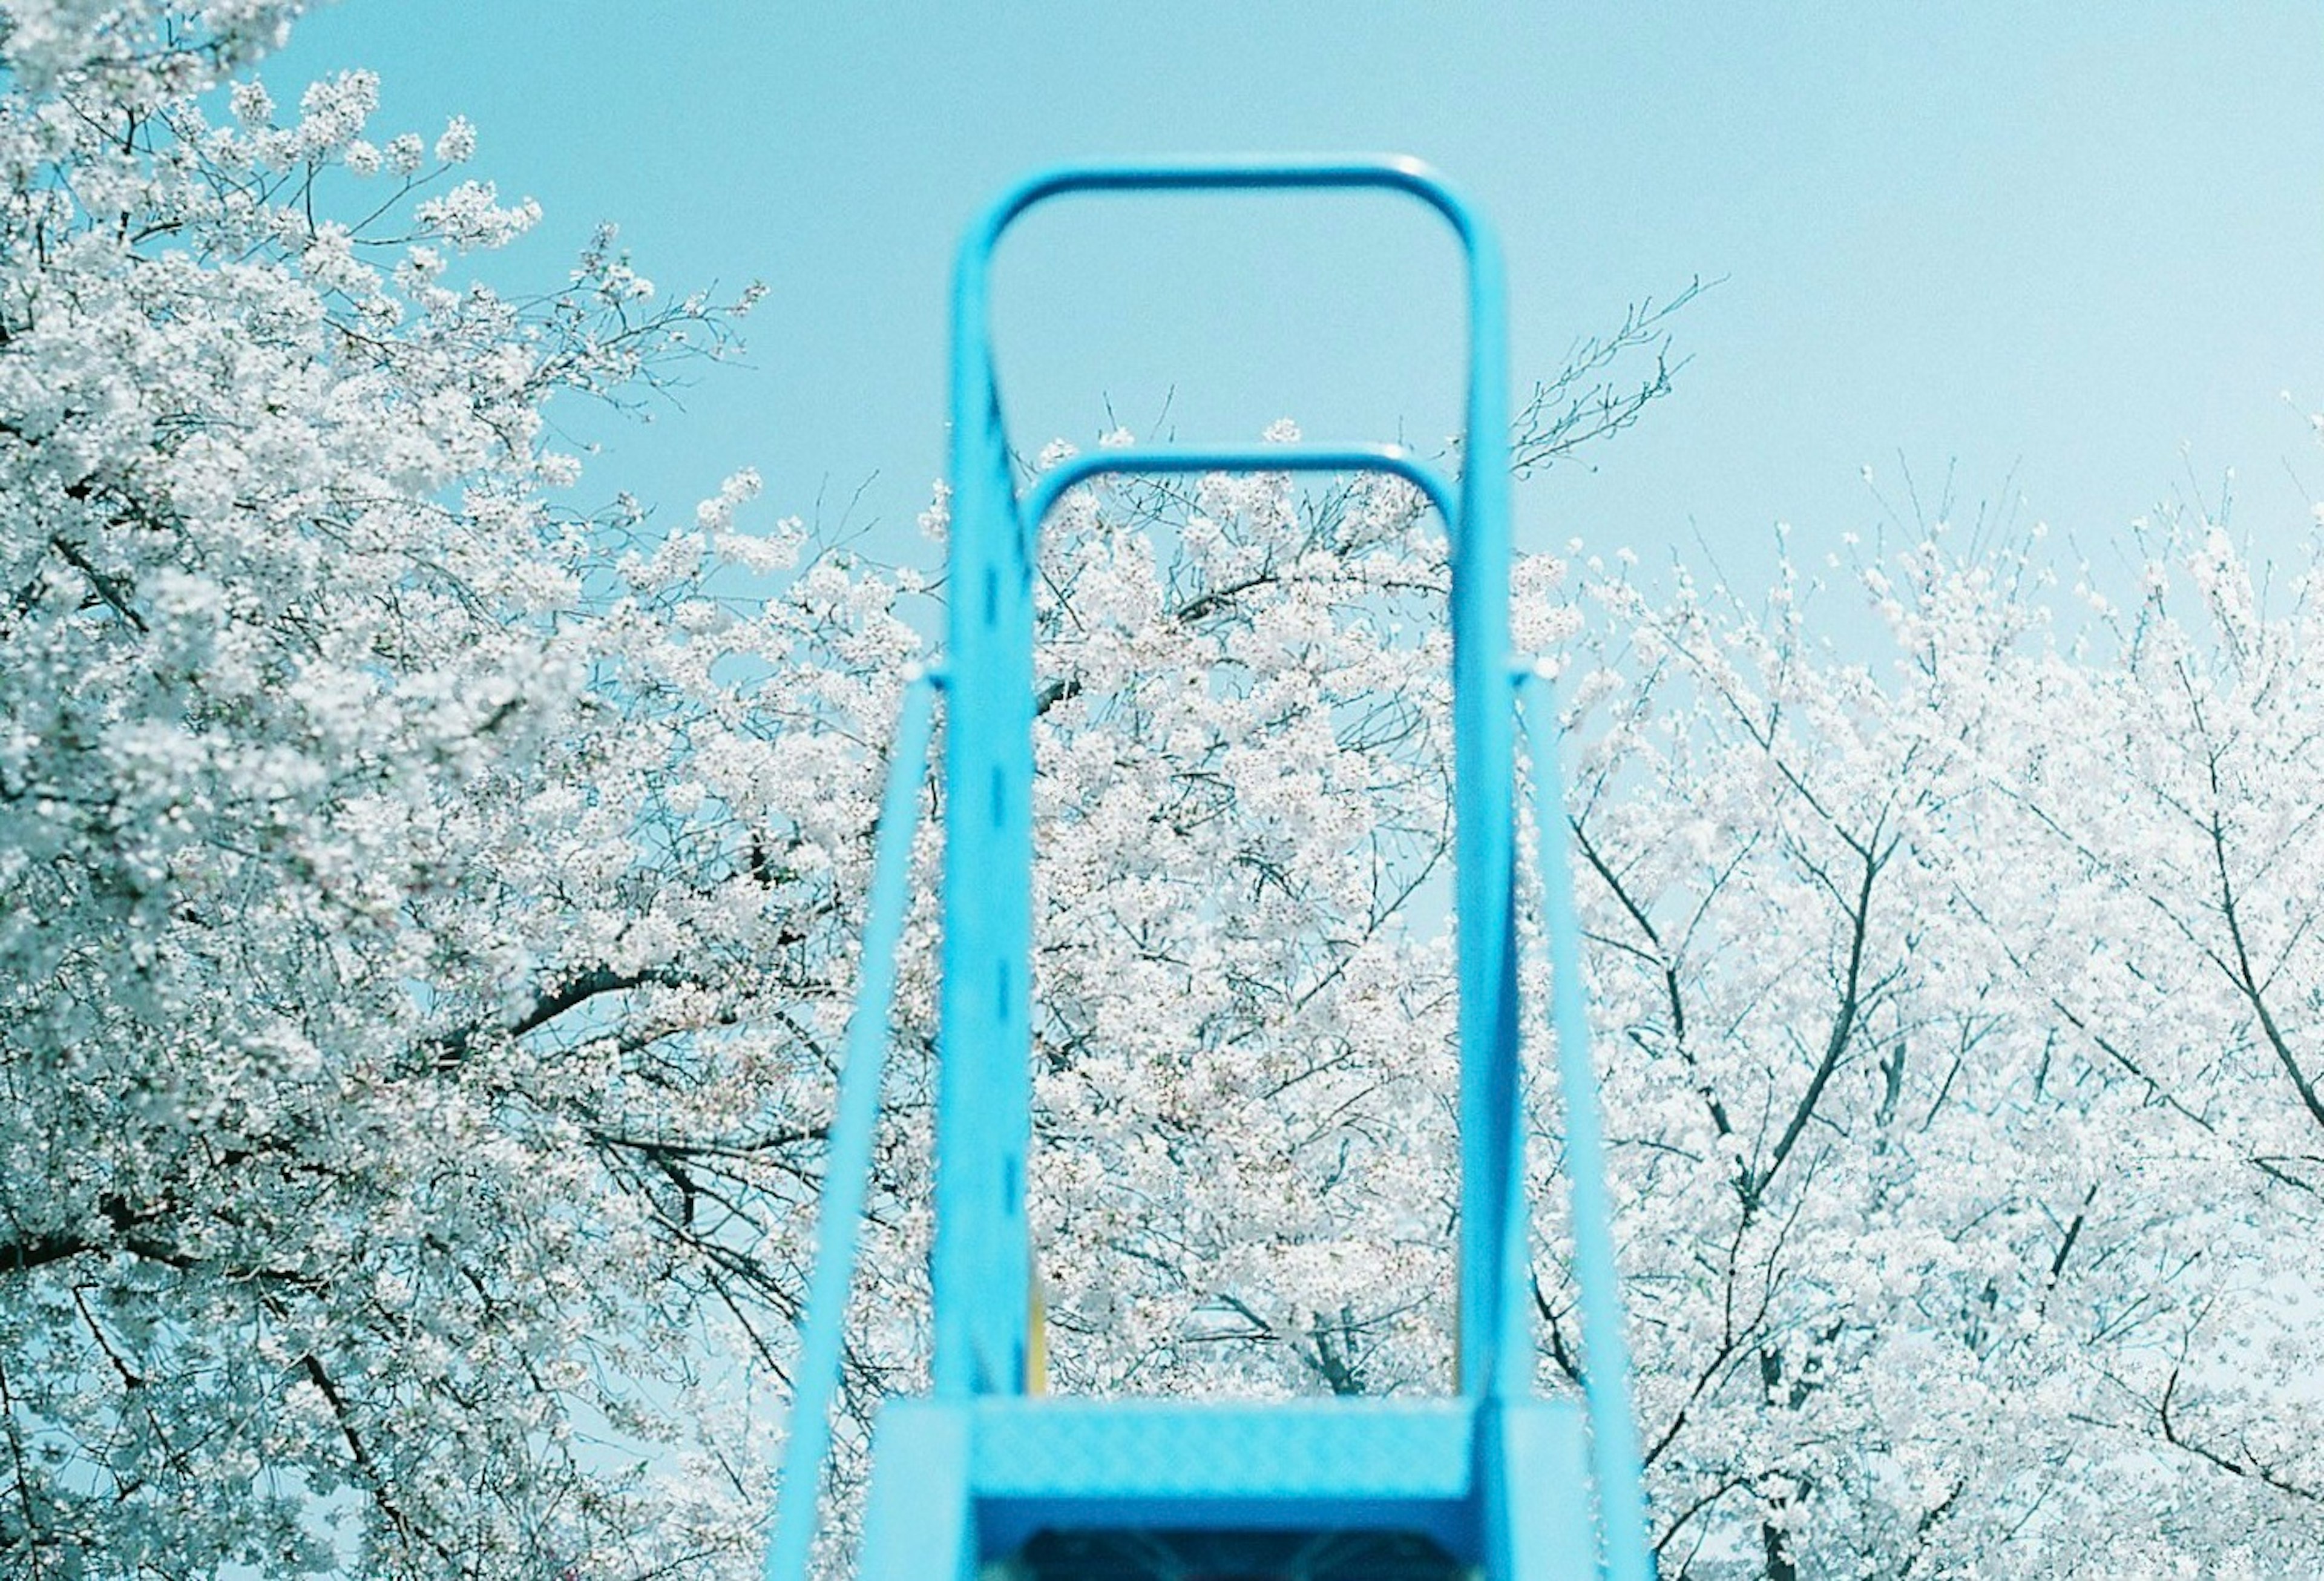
268;0;2324;593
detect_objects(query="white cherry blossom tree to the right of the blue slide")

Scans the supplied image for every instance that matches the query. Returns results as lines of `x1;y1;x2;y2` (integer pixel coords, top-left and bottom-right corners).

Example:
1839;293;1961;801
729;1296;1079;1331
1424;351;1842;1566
1541;525;2324;1579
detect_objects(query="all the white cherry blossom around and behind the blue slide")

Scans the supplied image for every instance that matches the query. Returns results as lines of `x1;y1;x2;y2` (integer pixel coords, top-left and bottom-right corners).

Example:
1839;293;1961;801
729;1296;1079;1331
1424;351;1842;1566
0;0;2324;1581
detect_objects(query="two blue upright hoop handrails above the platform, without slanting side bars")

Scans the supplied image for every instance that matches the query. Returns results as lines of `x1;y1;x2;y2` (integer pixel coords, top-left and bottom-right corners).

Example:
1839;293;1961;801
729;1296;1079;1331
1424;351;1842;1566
934;158;1532;1398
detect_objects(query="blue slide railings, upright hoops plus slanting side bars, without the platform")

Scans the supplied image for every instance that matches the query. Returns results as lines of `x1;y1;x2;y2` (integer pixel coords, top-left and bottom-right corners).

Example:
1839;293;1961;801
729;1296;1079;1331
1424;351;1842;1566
767;158;1652;1581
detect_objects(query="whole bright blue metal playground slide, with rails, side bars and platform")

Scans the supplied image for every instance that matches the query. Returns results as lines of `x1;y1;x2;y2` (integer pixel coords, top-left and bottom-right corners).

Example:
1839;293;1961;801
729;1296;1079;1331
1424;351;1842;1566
767;158;1650;1581
